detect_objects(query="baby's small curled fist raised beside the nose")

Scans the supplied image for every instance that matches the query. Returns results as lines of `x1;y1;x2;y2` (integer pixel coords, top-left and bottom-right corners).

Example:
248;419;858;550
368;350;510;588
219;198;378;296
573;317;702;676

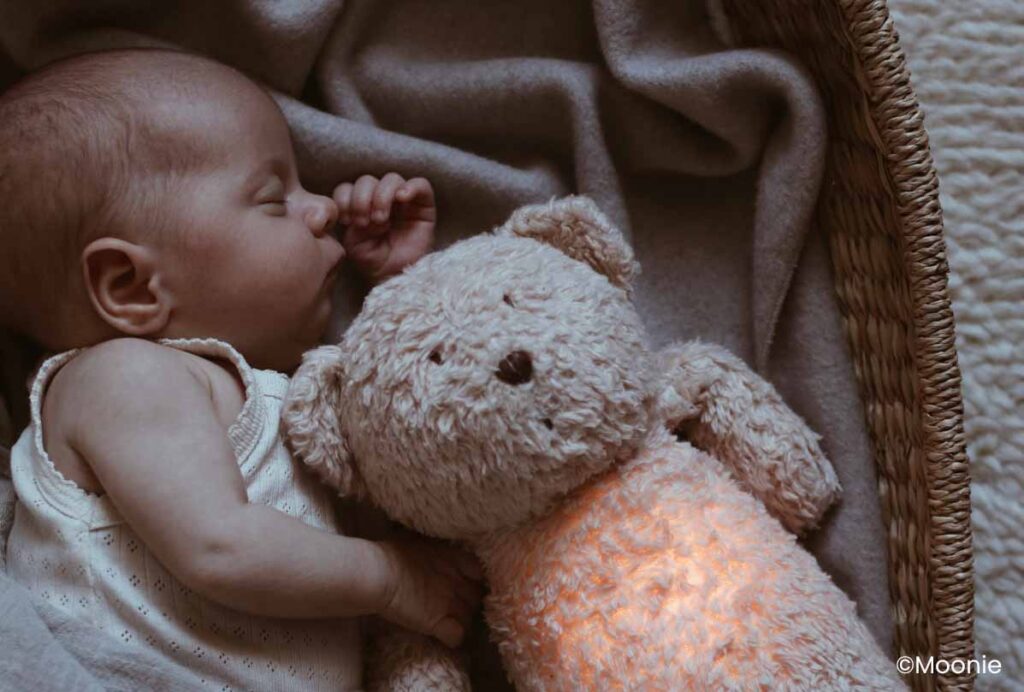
334;173;437;280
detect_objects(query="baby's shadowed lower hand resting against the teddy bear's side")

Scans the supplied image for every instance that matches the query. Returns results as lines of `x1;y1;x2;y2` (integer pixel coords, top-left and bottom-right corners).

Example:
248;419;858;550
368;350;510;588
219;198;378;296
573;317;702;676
378;537;481;647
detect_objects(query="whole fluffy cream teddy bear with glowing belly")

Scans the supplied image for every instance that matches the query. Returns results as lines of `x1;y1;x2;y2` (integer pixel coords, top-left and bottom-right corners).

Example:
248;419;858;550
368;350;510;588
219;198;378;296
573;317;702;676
284;197;903;690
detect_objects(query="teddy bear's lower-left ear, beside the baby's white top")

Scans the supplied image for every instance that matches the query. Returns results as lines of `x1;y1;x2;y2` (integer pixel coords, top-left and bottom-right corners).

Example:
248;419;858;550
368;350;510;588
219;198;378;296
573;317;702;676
281;346;366;498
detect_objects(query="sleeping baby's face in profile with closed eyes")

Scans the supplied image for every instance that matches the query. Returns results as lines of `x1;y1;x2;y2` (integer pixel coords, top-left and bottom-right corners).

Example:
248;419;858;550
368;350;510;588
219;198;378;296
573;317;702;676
148;73;344;371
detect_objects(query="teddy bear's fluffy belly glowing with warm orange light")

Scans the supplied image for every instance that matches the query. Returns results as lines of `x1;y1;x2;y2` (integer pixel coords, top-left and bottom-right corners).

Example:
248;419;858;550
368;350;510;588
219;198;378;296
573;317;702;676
483;444;895;690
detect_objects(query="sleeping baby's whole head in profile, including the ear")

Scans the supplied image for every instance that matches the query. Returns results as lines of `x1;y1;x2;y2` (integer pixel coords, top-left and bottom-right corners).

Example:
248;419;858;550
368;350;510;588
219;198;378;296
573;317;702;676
0;49;343;370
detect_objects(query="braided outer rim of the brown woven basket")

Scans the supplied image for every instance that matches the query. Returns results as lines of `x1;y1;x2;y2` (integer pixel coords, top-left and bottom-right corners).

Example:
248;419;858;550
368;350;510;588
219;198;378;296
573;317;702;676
840;0;974;671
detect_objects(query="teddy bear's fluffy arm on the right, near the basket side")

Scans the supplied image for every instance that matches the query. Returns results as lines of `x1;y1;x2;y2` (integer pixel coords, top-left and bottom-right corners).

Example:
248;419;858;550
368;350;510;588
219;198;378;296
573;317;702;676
658;341;841;533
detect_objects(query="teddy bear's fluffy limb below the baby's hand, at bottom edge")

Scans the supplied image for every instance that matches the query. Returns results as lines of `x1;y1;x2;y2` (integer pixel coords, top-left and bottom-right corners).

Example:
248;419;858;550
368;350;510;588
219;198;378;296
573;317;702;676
364;619;470;692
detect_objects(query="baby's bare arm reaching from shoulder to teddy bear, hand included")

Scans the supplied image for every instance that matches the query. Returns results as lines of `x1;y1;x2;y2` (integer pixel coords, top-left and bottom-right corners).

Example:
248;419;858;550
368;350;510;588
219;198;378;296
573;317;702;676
59;339;475;645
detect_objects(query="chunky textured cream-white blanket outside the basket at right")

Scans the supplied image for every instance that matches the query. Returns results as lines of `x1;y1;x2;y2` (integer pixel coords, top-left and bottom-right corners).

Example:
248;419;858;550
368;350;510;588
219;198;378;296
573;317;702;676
889;0;1024;690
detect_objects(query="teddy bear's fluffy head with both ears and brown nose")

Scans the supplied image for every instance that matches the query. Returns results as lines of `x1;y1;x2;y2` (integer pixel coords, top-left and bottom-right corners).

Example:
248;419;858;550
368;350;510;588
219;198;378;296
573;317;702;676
284;198;652;538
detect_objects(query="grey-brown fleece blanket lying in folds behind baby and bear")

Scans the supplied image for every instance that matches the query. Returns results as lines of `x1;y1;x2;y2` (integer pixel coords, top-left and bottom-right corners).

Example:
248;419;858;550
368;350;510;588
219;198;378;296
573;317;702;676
0;0;891;687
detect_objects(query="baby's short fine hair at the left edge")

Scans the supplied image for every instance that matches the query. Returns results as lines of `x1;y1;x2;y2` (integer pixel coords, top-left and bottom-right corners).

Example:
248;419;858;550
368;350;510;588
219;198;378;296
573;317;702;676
0;48;243;346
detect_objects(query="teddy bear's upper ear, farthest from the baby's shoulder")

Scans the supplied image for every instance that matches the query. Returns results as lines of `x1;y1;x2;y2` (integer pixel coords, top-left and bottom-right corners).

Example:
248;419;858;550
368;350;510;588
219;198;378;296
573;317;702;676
495;196;640;290
